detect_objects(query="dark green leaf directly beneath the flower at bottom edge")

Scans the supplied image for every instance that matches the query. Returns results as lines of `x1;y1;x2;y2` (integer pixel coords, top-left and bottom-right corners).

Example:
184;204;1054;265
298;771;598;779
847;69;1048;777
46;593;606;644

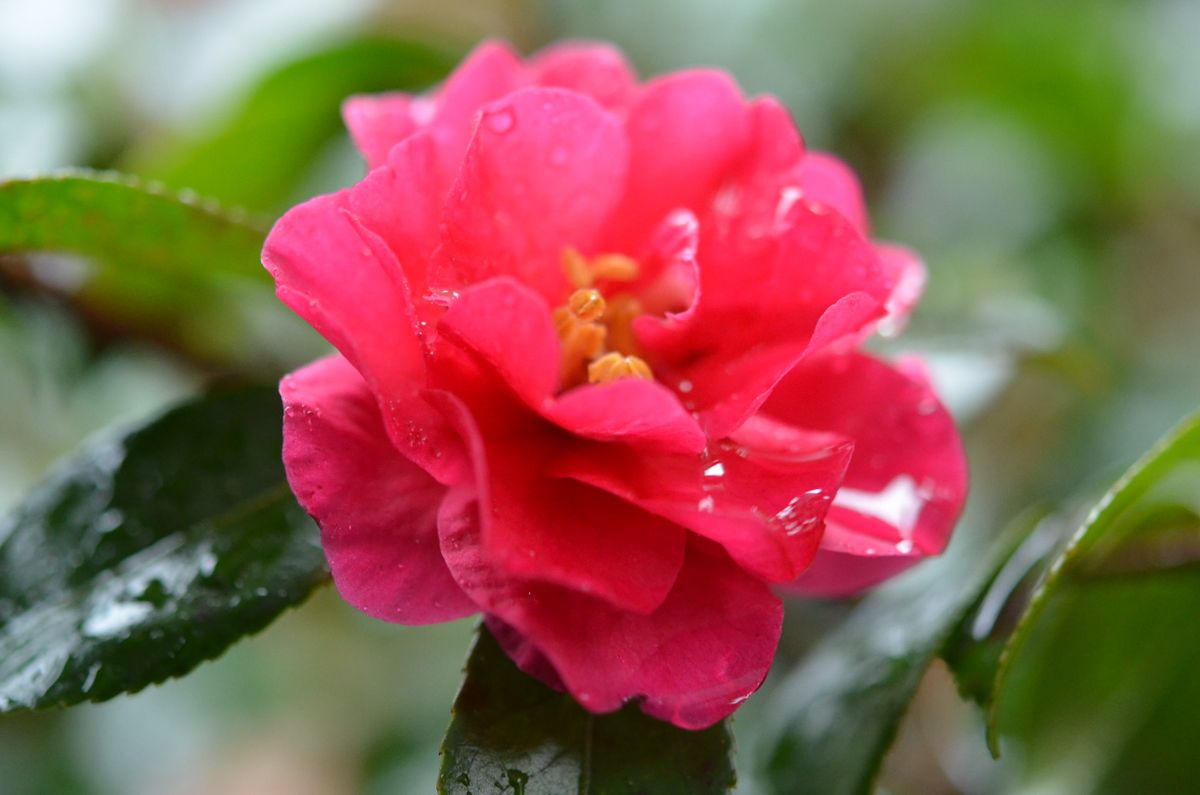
438;628;734;795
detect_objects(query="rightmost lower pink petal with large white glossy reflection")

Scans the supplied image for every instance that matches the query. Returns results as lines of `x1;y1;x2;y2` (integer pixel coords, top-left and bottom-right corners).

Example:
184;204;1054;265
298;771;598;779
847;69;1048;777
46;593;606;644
763;353;967;596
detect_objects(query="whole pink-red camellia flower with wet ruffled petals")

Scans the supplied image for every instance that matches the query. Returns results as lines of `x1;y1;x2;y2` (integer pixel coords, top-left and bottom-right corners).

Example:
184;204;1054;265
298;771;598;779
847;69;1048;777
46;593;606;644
263;43;966;728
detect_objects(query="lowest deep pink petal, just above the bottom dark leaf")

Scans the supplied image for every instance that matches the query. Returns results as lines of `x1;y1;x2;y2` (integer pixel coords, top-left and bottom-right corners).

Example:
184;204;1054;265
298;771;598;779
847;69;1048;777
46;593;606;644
438;491;782;729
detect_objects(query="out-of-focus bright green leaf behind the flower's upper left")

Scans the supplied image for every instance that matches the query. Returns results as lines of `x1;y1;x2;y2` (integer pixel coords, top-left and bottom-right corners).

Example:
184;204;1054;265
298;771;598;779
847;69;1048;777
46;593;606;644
126;36;457;211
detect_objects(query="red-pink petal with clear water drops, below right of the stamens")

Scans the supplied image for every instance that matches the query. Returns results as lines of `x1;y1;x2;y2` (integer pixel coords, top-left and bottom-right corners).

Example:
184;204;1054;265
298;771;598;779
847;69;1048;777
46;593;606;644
550;418;853;582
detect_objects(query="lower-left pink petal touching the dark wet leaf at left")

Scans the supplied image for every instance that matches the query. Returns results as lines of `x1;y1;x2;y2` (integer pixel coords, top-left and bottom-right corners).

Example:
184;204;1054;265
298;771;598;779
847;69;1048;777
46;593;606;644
280;355;476;624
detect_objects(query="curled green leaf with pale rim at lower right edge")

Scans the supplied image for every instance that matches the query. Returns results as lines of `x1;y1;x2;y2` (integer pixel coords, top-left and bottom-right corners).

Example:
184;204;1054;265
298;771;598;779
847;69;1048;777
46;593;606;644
989;413;1200;793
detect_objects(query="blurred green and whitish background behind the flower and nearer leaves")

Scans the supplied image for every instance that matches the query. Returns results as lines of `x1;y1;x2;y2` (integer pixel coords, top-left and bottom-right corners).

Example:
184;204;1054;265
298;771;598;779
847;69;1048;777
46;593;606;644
0;0;1200;795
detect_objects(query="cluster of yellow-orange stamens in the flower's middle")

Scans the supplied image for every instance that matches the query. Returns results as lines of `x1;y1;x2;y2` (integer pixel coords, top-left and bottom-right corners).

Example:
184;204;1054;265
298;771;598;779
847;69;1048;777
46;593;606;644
554;247;654;389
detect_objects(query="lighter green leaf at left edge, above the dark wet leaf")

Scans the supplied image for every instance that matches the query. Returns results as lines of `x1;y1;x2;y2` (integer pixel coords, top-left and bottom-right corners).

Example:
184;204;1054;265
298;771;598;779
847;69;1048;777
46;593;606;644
0;172;323;371
